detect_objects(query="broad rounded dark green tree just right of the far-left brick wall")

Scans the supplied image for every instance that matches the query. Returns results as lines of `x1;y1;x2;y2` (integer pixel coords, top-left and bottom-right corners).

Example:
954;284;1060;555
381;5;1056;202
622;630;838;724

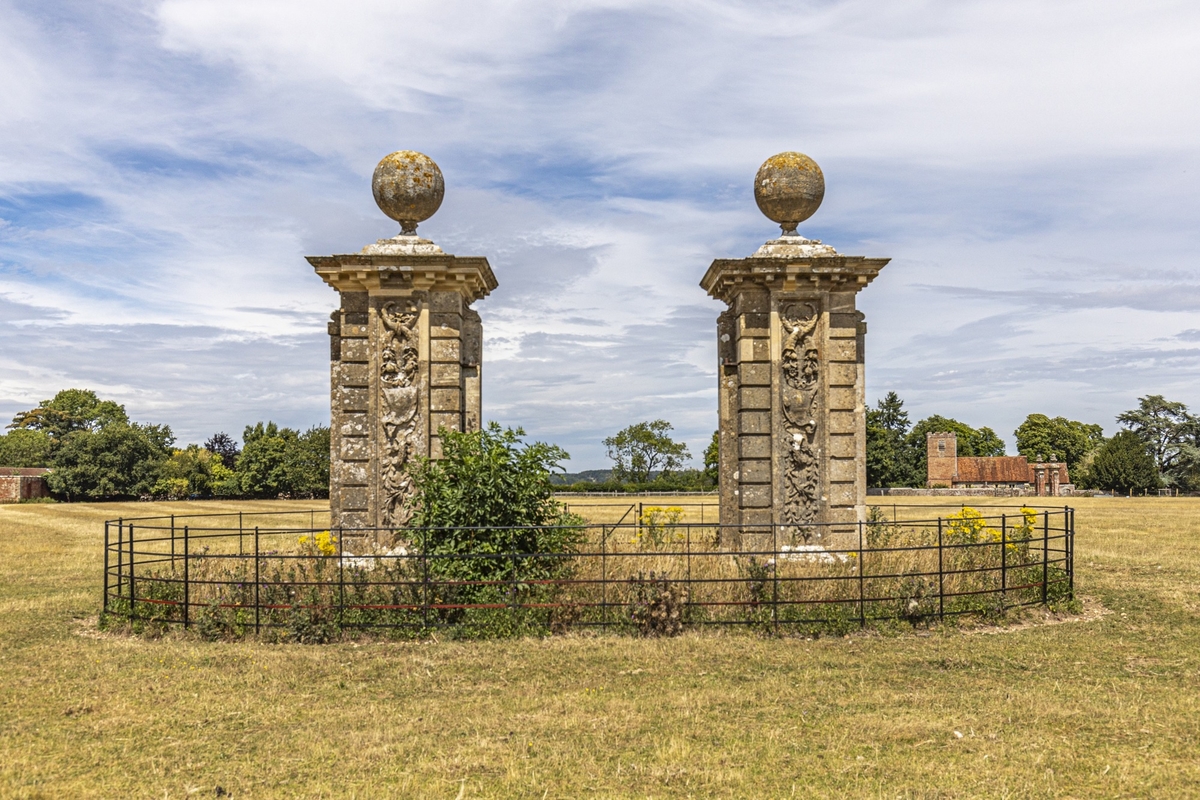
47;422;174;500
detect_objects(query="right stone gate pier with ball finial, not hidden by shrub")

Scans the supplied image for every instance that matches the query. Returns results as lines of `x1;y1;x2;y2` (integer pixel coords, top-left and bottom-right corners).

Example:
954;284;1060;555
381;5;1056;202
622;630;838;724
700;152;890;548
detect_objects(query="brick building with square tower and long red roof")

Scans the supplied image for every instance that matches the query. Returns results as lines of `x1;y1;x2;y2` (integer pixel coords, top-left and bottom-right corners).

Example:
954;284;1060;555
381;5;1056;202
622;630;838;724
925;433;1074;497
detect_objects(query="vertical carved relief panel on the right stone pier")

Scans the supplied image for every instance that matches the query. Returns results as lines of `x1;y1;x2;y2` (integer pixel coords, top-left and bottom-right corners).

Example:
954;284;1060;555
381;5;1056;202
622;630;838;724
780;303;821;539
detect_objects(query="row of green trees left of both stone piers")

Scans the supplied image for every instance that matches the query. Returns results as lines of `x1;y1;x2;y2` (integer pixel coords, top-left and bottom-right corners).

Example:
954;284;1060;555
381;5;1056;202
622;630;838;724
0;389;329;500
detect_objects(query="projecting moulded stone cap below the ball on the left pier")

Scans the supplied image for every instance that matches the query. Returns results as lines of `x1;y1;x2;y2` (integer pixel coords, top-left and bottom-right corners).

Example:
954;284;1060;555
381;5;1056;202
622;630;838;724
305;251;499;302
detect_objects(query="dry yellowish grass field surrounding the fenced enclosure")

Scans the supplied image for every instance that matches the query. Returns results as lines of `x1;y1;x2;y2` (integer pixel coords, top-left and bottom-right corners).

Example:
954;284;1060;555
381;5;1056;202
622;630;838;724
0;498;1200;798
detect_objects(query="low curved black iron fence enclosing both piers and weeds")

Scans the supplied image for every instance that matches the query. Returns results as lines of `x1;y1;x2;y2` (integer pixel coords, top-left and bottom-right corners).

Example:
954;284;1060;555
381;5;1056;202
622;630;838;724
103;506;1074;640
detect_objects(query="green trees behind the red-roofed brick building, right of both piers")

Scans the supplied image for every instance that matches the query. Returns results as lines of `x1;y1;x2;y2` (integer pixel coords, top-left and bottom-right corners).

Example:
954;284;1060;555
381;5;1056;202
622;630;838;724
866;392;1185;493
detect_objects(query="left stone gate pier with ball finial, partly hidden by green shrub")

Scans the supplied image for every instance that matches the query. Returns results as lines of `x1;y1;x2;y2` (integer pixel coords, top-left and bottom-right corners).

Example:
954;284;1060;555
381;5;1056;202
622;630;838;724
307;150;497;529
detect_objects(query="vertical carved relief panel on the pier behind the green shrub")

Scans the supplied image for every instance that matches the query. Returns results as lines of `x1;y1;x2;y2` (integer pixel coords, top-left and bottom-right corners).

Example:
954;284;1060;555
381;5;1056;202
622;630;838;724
379;302;420;528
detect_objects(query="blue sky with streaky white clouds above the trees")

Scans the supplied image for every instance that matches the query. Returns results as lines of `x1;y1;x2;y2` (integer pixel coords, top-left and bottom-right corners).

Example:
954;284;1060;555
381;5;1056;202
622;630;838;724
0;0;1200;471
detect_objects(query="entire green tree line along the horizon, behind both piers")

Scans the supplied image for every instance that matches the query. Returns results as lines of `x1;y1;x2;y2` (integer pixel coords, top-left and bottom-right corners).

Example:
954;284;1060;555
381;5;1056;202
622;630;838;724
7;389;1200;500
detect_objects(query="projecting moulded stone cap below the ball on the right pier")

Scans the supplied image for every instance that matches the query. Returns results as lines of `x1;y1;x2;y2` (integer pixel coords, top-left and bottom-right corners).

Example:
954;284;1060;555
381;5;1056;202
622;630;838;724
700;253;892;302
